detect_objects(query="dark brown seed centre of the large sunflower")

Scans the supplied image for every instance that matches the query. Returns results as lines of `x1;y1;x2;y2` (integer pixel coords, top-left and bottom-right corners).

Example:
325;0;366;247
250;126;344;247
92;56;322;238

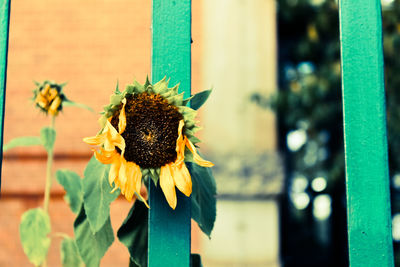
111;93;183;168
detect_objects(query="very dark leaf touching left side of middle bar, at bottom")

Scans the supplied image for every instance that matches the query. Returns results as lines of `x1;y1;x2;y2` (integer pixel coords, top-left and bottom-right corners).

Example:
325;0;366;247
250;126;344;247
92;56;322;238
117;201;149;267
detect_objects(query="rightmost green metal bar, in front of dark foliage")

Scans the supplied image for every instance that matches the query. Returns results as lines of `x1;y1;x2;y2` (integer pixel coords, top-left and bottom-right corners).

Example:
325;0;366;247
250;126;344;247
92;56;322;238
340;0;394;266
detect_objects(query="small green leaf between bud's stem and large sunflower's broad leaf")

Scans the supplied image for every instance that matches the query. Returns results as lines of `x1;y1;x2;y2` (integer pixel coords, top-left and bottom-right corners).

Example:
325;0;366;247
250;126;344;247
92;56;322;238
56;170;83;213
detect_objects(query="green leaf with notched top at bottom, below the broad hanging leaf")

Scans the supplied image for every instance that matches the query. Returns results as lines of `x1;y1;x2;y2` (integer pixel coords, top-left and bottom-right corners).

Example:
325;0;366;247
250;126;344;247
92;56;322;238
74;206;114;267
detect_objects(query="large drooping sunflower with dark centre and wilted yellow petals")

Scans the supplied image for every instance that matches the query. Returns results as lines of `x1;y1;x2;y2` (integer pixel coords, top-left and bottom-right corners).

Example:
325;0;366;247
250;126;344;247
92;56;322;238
84;78;213;209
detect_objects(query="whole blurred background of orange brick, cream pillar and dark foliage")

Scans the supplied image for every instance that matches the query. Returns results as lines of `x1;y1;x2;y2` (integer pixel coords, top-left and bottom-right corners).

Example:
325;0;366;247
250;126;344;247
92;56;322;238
0;0;400;267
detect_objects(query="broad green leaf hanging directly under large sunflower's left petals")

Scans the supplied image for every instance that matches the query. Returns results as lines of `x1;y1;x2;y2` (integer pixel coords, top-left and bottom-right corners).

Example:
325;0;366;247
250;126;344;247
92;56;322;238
82;156;120;233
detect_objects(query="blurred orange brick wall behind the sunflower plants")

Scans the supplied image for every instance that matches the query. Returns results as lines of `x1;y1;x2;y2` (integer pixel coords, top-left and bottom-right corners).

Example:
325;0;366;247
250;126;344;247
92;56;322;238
0;0;201;266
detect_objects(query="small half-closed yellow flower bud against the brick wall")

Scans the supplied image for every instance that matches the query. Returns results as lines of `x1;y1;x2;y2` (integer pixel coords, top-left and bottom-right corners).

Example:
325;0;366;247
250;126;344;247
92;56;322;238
33;81;66;116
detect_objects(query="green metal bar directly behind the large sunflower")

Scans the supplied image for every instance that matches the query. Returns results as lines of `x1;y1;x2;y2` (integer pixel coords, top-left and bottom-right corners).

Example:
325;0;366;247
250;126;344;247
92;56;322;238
149;0;191;267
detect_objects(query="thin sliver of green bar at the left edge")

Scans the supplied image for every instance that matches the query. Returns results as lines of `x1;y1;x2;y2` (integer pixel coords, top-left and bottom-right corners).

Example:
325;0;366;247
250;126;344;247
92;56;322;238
0;0;10;191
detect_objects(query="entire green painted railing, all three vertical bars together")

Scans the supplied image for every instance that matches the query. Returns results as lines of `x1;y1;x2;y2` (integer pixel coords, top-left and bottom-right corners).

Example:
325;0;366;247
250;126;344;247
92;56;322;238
0;0;393;267
